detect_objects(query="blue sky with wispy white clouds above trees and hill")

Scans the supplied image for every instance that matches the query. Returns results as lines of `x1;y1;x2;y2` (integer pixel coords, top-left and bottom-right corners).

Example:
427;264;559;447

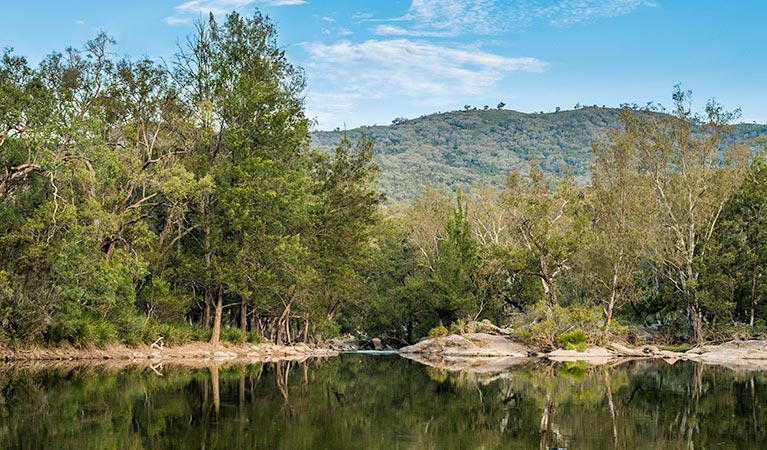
0;0;767;129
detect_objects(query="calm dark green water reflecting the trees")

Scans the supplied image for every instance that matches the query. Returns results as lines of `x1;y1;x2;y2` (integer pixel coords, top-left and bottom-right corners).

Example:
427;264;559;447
0;354;767;450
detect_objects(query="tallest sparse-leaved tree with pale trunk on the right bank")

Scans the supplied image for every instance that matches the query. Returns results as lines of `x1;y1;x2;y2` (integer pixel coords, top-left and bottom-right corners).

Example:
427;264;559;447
622;86;745;344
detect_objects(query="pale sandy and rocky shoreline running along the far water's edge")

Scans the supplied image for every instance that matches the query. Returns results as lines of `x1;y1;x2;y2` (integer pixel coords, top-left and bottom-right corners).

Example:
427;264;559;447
0;333;767;372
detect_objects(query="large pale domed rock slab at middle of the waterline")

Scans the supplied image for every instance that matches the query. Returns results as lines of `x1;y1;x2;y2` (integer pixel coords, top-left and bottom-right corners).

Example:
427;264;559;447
399;333;530;357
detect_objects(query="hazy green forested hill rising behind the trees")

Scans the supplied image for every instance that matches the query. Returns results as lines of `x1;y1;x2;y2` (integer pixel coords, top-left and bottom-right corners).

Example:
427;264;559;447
312;107;767;202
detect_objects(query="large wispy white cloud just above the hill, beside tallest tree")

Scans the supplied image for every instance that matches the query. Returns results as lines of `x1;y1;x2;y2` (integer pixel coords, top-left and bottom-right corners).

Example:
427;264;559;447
304;39;546;99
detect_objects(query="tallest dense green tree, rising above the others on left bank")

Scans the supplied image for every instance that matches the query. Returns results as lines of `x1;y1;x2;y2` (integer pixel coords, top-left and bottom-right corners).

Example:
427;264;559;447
176;13;312;344
